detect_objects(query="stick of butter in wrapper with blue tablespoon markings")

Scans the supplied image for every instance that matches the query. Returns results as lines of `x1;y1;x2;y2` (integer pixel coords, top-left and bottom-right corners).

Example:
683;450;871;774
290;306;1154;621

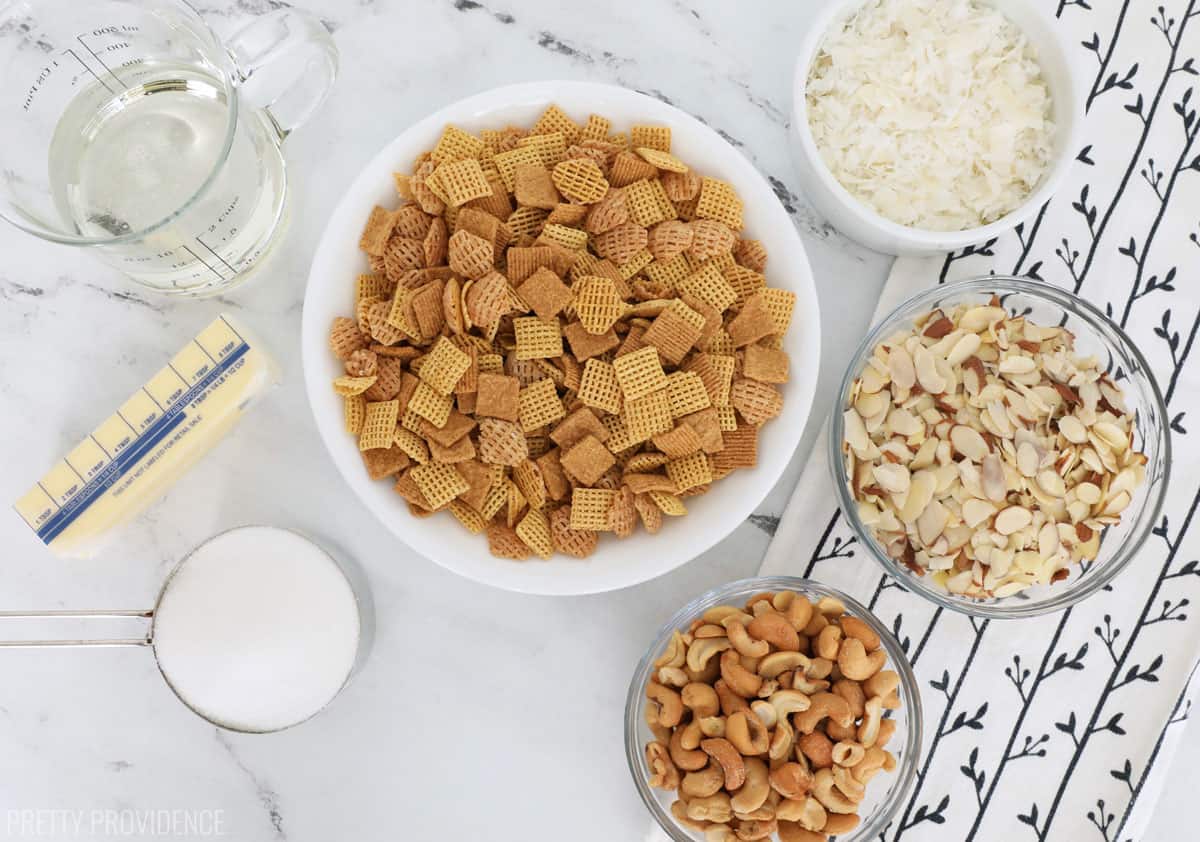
14;315;280;558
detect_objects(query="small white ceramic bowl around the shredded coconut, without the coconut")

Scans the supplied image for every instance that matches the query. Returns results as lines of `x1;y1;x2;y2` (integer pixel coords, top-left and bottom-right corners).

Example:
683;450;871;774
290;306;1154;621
788;0;1084;254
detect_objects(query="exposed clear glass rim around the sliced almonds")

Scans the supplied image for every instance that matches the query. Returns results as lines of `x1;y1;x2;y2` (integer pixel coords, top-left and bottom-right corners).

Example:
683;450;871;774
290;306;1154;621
827;275;1171;619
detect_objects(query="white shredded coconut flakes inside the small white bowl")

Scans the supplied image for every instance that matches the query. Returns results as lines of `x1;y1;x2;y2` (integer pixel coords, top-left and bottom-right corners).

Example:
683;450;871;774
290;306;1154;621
808;0;1055;231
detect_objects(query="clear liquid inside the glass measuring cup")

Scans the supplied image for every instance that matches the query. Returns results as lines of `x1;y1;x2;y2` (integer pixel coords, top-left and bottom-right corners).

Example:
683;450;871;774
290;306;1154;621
48;62;286;297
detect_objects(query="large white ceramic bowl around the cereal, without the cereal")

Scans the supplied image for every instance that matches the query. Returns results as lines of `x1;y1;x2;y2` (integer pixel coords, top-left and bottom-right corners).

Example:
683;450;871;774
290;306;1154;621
302;82;821;594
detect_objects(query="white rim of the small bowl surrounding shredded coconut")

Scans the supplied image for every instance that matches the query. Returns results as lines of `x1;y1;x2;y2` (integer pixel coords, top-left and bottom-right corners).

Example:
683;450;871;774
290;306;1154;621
792;0;1084;251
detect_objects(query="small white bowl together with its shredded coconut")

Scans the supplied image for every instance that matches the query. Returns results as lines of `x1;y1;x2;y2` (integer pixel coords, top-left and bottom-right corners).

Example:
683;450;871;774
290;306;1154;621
791;0;1084;254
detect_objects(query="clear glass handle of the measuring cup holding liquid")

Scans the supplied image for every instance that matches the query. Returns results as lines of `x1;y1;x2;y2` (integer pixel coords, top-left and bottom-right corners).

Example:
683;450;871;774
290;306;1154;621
227;8;337;137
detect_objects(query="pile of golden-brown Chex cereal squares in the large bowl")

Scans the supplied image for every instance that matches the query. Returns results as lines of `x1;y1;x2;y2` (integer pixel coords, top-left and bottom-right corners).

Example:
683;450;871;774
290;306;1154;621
329;106;796;563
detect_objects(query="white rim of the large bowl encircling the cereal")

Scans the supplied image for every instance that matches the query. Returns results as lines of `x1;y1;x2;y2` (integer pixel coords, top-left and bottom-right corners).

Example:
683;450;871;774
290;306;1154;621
301;80;821;595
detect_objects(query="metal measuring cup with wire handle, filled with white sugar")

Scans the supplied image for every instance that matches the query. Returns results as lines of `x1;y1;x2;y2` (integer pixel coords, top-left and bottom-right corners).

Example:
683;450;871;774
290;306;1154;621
0;527;374;733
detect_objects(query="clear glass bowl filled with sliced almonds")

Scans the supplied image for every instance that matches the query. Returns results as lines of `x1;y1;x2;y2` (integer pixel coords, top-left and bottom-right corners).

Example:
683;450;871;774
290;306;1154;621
829;276;1171;618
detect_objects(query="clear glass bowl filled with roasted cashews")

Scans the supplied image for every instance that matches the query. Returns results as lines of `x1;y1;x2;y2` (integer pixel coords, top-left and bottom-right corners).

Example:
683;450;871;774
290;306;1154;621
625;576;922;842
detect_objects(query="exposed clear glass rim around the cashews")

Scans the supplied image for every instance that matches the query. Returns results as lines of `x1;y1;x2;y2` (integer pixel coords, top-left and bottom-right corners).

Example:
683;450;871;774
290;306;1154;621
625;576;925;842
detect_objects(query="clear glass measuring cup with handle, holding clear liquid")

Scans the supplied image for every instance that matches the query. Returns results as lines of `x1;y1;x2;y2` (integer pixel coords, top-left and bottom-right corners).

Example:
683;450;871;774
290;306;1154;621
0;0;337;295
